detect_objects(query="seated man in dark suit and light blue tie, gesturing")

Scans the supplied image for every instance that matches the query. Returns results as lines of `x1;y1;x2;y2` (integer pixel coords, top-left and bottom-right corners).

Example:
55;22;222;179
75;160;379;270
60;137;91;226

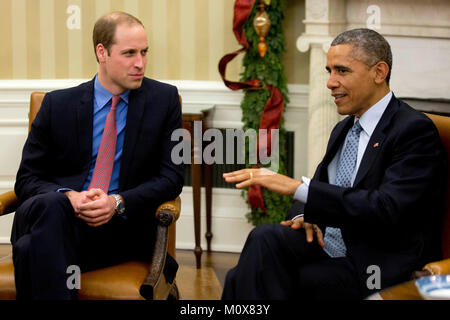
223;29;447;299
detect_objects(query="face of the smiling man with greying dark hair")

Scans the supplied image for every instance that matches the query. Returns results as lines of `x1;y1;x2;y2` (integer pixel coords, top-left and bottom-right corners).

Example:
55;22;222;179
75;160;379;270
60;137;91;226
326;44;378;117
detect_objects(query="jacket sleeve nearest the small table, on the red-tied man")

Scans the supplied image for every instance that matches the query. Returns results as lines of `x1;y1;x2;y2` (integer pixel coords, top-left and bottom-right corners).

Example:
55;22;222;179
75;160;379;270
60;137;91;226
120;88;184;214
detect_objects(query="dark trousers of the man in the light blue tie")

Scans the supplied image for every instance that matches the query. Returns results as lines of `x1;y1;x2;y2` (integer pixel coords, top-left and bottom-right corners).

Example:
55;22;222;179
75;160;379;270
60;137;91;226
222;224;363;303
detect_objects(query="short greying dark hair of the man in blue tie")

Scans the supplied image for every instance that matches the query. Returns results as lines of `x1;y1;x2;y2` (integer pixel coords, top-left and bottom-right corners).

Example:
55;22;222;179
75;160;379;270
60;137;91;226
331;28;392;84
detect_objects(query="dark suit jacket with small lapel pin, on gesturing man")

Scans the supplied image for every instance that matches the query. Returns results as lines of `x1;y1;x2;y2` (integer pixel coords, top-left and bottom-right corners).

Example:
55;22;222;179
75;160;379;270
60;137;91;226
288;96;447;293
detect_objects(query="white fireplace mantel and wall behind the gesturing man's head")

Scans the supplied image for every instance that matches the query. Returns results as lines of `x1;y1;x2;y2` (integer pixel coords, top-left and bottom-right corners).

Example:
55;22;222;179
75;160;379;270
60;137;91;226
346;0;450;99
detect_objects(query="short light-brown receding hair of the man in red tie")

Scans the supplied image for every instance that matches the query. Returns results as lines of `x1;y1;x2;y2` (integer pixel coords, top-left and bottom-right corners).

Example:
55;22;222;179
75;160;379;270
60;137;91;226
92;11;144;62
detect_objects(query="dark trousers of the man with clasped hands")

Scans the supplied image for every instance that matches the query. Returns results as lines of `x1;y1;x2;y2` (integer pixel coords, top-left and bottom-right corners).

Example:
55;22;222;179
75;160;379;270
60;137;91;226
11;192;176;300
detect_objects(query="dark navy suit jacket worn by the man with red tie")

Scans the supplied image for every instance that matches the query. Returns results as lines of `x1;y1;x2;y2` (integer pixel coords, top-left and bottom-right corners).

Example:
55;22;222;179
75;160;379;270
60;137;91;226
15;78;184;224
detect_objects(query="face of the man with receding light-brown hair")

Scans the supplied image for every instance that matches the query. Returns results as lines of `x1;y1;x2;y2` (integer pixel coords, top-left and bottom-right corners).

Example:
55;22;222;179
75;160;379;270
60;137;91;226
99;23;148;94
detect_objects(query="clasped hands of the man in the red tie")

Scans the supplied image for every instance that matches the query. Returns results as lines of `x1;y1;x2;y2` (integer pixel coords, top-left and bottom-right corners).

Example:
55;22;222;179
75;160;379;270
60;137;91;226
65;189;116;227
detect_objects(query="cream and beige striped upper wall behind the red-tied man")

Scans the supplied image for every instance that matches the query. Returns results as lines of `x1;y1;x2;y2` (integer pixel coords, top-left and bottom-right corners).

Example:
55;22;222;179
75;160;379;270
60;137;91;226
0;0;309;84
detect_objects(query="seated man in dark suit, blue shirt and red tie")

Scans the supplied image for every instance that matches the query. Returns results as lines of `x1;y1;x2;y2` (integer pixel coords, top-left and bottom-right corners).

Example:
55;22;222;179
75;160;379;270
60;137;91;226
11;12;183;299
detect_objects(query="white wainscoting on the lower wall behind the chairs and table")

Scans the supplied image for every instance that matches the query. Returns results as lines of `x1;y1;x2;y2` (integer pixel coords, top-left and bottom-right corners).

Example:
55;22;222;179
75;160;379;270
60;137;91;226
0;79;308;252
